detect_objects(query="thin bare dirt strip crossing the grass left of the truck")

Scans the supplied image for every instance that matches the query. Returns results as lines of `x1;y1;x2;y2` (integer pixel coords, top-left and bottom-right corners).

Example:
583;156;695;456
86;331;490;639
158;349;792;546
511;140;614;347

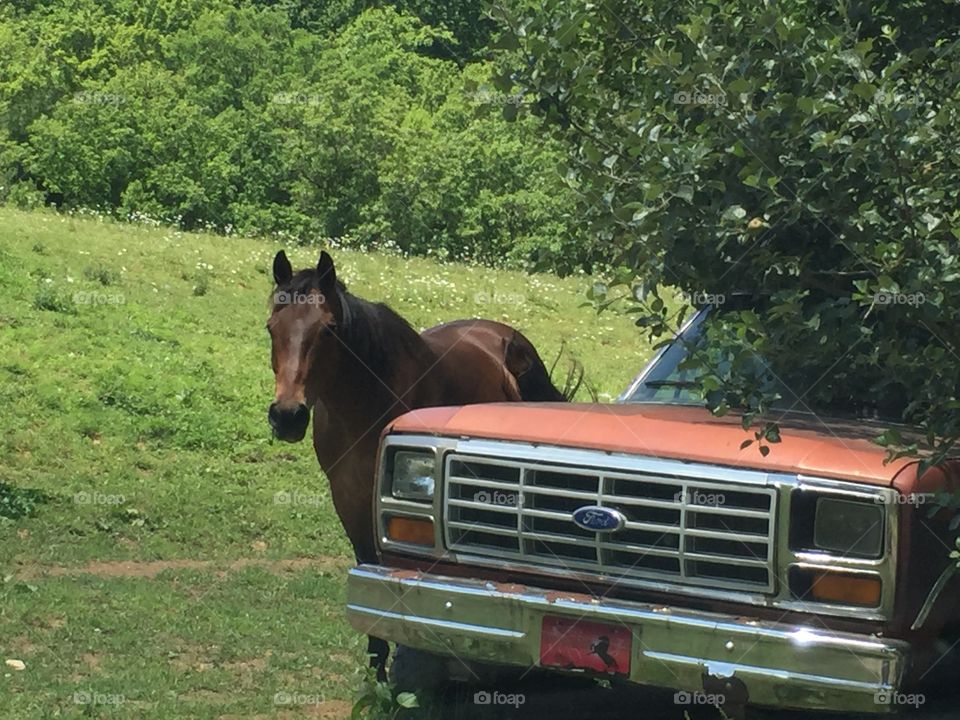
16;556;352;580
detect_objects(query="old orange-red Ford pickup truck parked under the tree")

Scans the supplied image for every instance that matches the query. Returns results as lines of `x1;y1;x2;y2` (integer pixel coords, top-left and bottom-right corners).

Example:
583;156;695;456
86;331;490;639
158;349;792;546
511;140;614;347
347;311;960;714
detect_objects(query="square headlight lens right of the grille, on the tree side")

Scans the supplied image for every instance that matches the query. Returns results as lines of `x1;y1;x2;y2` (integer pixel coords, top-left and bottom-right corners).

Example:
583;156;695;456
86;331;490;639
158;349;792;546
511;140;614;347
813;498;884;558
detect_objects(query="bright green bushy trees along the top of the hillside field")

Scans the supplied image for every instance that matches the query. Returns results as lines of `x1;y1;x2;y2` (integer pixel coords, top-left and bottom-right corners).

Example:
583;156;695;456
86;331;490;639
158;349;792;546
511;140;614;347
0;0;575;265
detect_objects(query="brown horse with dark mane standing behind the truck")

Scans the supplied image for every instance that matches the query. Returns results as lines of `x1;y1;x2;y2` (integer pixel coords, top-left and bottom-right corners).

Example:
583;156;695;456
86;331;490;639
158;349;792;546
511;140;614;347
267;250;582;679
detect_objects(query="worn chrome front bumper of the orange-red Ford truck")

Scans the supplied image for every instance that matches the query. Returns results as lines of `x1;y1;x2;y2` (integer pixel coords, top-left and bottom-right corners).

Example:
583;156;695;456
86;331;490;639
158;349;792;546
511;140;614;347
347;565;909;713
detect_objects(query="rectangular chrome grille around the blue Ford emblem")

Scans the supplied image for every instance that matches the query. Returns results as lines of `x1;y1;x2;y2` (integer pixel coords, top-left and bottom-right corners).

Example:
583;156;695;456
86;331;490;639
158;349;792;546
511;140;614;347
444;453;776;593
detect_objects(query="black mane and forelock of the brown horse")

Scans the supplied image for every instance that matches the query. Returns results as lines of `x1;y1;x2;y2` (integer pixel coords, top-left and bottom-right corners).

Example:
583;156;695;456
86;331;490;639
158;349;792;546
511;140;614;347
284;268;426;381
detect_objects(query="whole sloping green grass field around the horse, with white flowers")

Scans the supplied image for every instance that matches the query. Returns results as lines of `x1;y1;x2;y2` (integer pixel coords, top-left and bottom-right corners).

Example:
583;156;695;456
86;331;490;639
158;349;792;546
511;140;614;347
0;208;650;718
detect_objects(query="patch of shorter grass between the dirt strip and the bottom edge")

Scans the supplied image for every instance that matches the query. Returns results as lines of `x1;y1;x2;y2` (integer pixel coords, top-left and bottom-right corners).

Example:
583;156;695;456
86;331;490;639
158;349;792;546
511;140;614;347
0;569;359;719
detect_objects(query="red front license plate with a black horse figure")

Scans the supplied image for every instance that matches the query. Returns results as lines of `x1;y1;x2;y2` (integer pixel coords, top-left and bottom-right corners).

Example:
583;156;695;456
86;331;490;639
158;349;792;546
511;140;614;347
540;615;632;675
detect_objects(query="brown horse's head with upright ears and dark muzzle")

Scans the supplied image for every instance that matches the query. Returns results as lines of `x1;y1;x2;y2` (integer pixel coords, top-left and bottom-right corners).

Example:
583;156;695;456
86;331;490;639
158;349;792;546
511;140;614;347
267;250;342;442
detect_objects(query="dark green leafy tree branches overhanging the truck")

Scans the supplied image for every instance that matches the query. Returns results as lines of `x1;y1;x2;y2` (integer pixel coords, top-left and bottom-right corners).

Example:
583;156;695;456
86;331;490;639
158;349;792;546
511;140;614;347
495;0;960;460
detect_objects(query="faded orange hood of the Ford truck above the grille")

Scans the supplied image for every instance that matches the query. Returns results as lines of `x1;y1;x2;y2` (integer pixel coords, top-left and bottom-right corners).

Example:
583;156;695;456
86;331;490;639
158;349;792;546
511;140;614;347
388;403;916;486
